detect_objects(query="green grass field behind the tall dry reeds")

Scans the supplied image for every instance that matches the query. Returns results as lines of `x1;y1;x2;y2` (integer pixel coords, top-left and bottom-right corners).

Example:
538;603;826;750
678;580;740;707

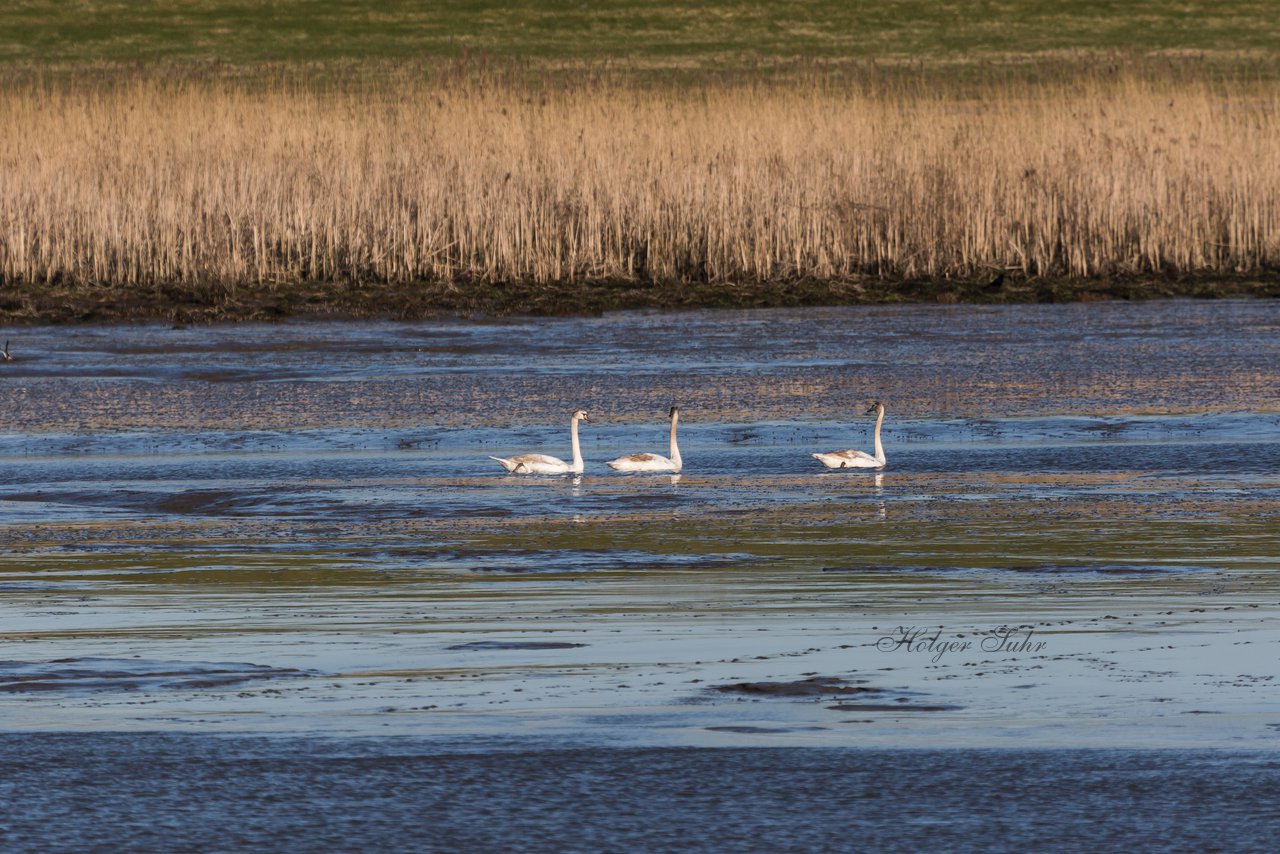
0;0;1280;69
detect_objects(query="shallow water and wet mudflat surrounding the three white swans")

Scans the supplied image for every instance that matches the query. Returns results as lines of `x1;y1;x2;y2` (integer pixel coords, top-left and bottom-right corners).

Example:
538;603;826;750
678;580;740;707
0;302;1280;749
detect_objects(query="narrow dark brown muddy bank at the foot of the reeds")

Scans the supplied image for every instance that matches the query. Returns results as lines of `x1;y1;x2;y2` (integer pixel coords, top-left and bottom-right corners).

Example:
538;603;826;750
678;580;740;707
0;274;1280;324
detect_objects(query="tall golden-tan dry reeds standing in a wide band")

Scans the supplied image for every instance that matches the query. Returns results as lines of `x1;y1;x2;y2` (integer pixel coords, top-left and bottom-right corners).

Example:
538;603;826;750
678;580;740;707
0;71;1280;287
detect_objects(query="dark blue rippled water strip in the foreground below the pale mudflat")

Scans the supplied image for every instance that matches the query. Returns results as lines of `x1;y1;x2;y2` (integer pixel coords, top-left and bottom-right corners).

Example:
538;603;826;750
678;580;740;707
0;735;1280;851
